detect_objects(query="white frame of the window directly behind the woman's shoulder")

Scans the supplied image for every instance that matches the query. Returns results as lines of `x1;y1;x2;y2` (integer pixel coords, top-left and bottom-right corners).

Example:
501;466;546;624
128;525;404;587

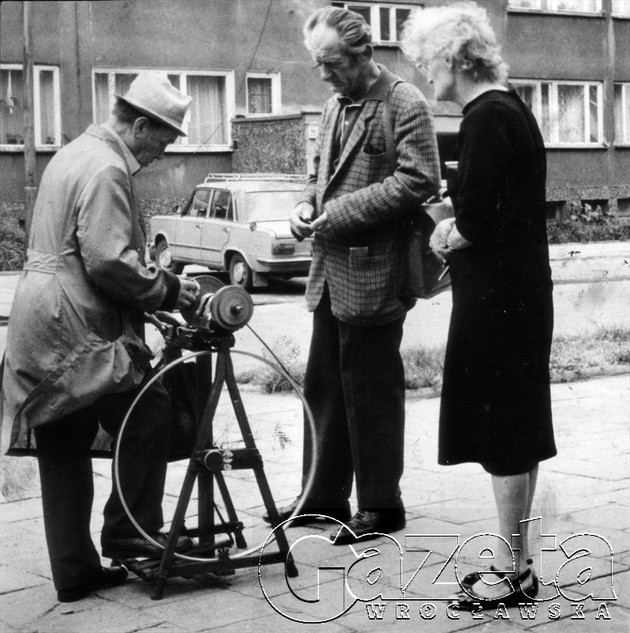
510;78;607;149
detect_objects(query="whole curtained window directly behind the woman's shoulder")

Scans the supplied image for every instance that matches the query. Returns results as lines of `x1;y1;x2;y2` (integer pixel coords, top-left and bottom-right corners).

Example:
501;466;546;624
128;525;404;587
512;79;604;145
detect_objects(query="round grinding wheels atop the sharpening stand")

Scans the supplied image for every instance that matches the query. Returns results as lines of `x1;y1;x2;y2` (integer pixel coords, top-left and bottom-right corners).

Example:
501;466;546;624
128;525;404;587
181;275;254;332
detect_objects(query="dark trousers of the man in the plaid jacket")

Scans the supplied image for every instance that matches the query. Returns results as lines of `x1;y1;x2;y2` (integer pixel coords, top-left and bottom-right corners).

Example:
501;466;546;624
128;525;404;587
303;292;405;510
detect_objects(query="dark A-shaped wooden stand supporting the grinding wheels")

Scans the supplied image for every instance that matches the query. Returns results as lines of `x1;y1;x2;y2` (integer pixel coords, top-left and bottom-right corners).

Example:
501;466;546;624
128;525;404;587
124;333;298;600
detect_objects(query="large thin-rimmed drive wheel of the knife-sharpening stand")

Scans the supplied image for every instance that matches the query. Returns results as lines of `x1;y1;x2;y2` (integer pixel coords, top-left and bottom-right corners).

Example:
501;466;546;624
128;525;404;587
113;350;317;562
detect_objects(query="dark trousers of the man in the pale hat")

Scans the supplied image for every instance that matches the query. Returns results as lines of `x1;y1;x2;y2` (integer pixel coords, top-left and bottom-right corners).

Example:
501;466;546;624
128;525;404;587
35;376;171;590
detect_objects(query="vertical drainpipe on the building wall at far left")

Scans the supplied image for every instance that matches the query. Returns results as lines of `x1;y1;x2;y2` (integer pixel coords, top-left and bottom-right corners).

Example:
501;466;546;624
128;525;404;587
22;2;37;239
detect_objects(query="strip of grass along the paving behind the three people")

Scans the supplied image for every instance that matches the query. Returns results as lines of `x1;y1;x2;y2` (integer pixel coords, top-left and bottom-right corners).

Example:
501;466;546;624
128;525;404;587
237;327;630;395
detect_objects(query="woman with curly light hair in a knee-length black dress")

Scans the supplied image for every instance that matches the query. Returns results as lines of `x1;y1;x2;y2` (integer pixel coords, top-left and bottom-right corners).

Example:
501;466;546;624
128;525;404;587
403;3;556;608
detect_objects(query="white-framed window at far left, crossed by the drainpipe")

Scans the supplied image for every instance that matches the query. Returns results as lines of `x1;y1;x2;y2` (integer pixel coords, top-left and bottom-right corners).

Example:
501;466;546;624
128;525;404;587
0;64;61;149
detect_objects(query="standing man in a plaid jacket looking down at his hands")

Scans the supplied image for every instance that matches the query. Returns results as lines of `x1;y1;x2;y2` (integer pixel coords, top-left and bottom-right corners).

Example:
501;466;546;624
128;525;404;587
280;7;440;544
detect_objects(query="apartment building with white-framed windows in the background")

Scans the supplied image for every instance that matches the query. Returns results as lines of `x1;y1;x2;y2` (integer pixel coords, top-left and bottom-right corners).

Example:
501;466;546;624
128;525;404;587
0;0;630;218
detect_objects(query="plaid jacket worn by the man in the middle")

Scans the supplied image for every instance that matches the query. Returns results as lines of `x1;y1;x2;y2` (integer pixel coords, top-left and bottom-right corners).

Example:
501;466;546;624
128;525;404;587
302;66;440;326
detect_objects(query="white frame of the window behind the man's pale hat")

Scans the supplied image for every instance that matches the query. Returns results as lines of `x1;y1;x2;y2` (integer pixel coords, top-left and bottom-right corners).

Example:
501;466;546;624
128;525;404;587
92;67;235;154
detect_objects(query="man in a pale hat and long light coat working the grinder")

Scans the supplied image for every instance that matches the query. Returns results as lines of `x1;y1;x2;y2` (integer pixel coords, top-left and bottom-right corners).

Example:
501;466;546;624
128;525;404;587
2;72;197;602
